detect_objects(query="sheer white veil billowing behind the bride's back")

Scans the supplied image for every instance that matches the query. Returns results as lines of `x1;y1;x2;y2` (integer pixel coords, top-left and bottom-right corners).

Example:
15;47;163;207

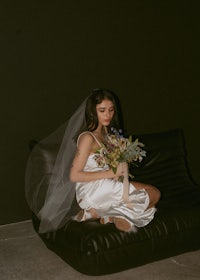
25;95;88;233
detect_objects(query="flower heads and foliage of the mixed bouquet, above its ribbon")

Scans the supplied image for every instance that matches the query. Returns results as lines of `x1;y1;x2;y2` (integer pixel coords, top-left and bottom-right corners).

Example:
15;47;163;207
95;129;146;176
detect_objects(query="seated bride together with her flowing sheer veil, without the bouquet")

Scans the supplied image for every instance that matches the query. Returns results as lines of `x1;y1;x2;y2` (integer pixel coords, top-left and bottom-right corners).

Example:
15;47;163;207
25;89;160;233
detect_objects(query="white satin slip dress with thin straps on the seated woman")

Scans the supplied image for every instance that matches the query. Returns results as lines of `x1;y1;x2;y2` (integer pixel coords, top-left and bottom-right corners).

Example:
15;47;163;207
76;132;156;227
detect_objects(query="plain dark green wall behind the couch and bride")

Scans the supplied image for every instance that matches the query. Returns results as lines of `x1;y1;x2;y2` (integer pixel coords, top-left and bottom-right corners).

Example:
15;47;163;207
0;0;200;224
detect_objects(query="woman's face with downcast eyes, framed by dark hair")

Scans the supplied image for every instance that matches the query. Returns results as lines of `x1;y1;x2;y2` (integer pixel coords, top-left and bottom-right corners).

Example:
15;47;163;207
96;99;115;126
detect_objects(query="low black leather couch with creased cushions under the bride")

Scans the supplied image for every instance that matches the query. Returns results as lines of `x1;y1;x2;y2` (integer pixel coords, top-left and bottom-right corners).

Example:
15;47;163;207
29;129;200;275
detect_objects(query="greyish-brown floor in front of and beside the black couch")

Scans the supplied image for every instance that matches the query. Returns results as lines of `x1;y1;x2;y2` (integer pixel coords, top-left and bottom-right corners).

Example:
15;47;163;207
0;221;200;280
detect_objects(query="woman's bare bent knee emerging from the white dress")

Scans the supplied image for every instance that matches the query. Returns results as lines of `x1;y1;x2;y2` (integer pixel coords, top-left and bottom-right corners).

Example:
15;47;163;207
130;182;160;209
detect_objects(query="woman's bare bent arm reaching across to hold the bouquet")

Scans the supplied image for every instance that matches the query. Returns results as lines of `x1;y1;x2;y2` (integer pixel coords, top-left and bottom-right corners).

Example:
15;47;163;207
70;133;123;182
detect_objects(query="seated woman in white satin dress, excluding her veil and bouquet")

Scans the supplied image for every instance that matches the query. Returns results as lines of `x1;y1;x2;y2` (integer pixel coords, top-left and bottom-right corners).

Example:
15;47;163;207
70;90;160;231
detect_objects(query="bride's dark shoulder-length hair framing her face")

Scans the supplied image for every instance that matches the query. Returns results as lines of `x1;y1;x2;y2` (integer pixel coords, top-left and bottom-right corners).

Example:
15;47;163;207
85;89;122;131
